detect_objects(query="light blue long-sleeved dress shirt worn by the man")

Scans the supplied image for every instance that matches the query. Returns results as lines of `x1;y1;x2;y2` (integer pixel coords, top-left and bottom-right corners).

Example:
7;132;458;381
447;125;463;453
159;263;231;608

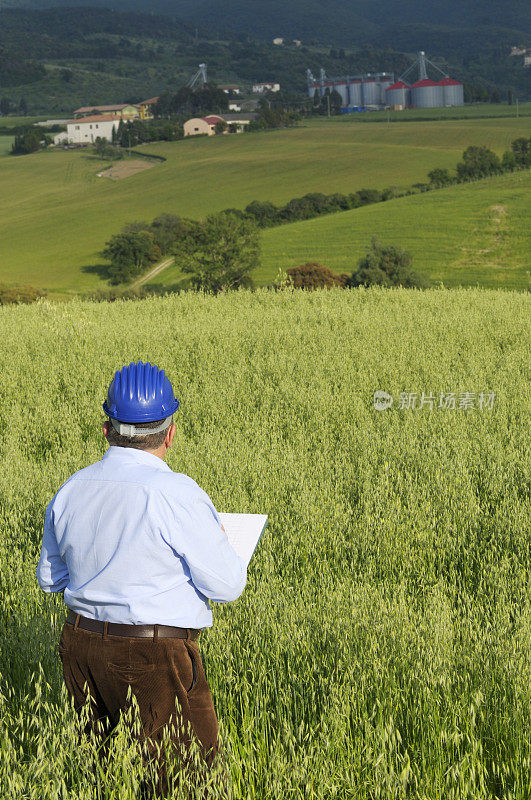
37;447;247;628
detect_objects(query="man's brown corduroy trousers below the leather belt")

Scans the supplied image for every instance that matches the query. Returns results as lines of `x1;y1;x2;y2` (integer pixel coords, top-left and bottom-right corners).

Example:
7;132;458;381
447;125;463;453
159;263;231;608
58;623;218;797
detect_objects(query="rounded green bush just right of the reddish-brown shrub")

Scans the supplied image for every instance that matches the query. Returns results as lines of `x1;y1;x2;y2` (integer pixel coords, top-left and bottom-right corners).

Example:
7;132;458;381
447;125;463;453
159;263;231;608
347;238;427;288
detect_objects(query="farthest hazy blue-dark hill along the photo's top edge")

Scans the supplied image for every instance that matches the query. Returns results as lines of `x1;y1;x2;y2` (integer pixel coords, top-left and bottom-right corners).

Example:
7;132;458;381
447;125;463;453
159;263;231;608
0;0;531;56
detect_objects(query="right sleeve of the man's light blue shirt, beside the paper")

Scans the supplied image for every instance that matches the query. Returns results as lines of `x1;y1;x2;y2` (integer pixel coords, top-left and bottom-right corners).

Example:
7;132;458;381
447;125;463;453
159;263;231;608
167;493;247;603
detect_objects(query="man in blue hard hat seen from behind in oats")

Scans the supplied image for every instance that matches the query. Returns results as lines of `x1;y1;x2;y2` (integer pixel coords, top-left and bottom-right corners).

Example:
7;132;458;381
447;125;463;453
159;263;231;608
37;361;246;792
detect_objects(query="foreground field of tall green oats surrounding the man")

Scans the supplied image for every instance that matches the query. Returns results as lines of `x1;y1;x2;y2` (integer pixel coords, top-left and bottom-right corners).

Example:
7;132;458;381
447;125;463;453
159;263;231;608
0;290;531;800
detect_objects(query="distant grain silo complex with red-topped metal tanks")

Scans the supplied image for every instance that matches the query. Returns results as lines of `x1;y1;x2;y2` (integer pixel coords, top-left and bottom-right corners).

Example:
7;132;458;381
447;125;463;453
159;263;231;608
306;51;464;114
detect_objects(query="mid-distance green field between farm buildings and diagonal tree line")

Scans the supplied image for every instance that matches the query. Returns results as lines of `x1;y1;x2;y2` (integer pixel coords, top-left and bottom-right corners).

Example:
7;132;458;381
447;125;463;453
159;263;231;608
0;119;529;295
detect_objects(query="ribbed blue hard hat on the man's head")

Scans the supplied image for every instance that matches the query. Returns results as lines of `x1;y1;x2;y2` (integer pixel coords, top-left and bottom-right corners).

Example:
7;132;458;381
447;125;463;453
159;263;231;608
103;361;179;423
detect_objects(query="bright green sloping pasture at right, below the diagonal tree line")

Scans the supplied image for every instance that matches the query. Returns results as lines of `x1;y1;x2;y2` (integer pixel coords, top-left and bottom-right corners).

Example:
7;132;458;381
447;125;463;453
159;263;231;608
256;171;531;289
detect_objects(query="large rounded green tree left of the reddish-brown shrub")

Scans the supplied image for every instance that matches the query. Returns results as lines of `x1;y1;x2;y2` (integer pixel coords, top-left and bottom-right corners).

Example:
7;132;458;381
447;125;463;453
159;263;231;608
181;211;260;293
